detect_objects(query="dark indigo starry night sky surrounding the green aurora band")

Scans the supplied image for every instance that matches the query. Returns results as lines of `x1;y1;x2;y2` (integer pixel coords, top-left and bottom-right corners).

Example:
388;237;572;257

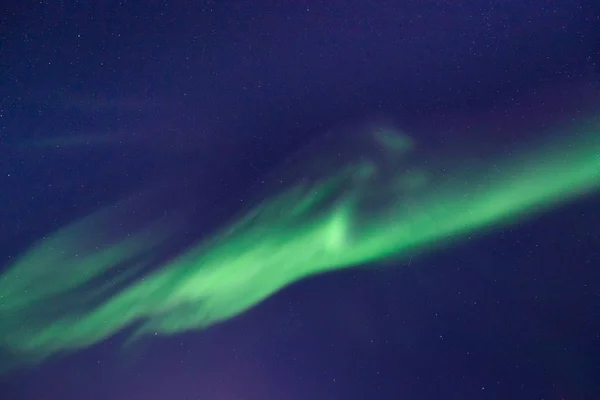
0;0;600;400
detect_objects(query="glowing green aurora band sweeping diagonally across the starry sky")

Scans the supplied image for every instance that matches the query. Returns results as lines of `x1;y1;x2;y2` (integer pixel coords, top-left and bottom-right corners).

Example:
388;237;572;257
0;118;600;371
